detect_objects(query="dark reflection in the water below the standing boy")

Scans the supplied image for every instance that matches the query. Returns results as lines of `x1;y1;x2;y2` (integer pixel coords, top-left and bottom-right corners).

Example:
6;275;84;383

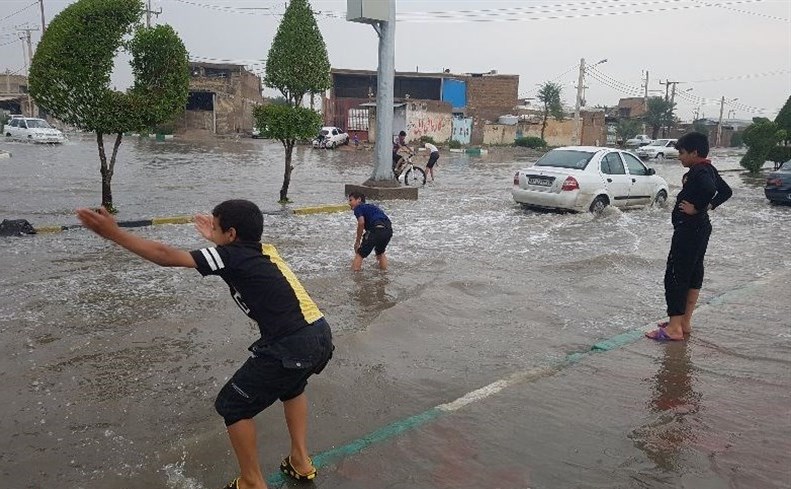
631;341;701;470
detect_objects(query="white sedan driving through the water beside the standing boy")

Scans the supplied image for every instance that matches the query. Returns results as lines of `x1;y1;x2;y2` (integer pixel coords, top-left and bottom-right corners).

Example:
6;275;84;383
511;146;668;213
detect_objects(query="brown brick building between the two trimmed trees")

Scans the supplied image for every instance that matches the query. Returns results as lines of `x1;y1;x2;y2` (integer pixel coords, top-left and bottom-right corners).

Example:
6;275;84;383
176;63;264;135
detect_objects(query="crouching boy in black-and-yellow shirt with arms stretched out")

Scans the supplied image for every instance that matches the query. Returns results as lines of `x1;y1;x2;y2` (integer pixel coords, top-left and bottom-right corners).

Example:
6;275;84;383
77;200;333;489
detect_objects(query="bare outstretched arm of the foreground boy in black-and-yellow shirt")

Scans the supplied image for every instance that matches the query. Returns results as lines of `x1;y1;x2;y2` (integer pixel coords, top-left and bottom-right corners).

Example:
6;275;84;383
77;207;196;268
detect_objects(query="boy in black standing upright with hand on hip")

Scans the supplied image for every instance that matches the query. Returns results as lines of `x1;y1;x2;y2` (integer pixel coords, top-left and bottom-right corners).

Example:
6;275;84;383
646;132;733;341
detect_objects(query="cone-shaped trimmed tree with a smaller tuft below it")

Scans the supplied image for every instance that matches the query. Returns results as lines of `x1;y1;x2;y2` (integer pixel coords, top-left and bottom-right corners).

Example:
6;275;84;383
256;0;332;203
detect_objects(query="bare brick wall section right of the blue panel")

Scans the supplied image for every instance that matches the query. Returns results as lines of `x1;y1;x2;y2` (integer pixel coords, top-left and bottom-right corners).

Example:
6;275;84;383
465;74;519;144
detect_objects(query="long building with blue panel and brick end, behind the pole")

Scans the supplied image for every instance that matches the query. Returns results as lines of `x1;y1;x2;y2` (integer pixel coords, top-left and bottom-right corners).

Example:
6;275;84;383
323;69;519;144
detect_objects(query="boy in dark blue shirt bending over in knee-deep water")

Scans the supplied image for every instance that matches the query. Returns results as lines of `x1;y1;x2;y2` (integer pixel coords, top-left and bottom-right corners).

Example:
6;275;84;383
349;192;393;272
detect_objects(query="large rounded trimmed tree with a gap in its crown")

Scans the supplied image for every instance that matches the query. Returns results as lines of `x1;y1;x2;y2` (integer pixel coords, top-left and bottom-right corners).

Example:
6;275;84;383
30;0;189;211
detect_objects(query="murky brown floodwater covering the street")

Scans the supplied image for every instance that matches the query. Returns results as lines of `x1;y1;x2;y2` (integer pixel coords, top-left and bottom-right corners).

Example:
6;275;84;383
0;138;791;489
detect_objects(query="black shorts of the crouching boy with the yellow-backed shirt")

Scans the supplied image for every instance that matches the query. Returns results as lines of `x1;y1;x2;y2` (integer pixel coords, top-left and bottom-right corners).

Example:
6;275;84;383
214;318;334;426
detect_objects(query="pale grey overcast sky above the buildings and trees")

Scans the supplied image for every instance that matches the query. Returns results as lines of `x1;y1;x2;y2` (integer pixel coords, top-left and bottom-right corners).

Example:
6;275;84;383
0;0;791;119
